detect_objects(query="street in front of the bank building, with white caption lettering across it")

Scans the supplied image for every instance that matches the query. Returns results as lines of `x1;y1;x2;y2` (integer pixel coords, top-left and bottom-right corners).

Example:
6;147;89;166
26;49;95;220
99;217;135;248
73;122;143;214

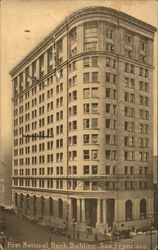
1;213;157;250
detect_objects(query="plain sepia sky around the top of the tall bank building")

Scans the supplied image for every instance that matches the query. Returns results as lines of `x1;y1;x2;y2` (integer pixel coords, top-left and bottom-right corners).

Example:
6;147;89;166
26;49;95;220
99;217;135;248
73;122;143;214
0;0;158;154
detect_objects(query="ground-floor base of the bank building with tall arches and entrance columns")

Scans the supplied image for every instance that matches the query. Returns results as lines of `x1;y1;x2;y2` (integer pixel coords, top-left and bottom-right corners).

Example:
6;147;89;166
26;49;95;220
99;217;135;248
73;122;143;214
13;190;153;241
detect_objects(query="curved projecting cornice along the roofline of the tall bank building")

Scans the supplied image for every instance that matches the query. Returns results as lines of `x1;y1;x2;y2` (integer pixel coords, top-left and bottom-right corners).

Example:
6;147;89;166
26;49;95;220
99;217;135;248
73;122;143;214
9;6;157;77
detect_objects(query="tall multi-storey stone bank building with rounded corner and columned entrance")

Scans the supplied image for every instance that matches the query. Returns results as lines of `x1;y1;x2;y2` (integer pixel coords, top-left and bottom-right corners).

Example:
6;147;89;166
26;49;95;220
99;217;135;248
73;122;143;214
10;7;156;236
